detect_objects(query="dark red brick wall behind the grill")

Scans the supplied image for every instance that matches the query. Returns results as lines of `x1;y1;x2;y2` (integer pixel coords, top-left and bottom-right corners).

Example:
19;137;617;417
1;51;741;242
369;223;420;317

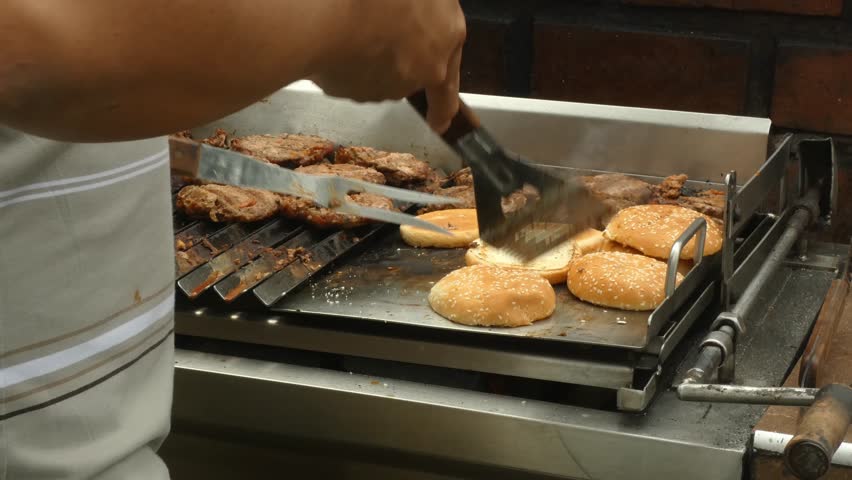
462;0;852;242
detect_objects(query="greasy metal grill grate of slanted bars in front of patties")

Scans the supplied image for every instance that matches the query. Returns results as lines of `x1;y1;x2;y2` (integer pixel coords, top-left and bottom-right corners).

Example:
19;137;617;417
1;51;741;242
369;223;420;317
173;189;394;307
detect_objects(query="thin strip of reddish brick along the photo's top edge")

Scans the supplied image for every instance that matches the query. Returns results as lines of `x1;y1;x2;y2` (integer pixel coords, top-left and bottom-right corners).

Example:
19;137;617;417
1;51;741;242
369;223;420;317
623;0;843;17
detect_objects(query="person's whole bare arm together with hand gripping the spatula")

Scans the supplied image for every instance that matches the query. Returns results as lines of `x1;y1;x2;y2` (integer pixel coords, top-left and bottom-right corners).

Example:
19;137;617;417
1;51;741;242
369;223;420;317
0;0;465;142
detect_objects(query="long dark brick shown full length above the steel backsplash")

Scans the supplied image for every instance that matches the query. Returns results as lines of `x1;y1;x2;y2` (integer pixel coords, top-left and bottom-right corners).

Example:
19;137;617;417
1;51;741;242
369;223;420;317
533;24;749;114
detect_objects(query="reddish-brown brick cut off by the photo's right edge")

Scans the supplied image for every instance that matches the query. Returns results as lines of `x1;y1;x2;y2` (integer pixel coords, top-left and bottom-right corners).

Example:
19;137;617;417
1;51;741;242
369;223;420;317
771;45;852;134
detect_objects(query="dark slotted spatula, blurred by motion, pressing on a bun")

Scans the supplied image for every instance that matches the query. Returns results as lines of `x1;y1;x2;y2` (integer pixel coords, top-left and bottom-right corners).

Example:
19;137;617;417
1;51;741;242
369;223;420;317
408;91;607;259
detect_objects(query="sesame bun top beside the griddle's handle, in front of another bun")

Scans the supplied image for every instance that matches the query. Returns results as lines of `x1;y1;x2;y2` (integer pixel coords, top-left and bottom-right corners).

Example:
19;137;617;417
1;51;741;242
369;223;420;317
567;252;683;311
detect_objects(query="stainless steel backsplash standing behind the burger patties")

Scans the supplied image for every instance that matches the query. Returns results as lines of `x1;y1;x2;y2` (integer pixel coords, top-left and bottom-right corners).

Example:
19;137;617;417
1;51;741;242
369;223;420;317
197;82;771;182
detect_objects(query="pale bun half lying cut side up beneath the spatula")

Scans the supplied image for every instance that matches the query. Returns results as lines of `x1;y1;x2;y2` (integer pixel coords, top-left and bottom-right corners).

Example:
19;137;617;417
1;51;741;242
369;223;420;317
464;233;580;285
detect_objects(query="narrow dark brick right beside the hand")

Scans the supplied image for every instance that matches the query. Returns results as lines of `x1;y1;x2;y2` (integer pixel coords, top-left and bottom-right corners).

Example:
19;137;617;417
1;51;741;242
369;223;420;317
461;19;509;95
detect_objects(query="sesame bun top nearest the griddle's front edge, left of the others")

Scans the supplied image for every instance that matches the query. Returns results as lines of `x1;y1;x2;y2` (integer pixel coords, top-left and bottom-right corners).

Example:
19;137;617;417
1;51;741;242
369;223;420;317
429;265;556;327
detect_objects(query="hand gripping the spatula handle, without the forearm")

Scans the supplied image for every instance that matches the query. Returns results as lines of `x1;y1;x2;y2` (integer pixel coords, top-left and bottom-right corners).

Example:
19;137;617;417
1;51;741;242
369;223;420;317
311;0;466;132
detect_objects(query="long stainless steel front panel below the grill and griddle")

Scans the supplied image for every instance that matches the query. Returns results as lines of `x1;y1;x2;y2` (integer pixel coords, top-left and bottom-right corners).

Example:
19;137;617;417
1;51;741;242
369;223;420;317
174;350;755;480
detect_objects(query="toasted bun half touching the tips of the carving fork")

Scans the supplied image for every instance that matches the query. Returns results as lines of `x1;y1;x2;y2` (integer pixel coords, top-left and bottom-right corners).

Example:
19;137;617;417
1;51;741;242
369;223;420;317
399;208;479;248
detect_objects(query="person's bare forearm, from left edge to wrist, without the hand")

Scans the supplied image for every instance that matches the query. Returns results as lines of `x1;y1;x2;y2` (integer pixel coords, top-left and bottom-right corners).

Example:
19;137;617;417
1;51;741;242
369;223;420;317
0;0;357;141
